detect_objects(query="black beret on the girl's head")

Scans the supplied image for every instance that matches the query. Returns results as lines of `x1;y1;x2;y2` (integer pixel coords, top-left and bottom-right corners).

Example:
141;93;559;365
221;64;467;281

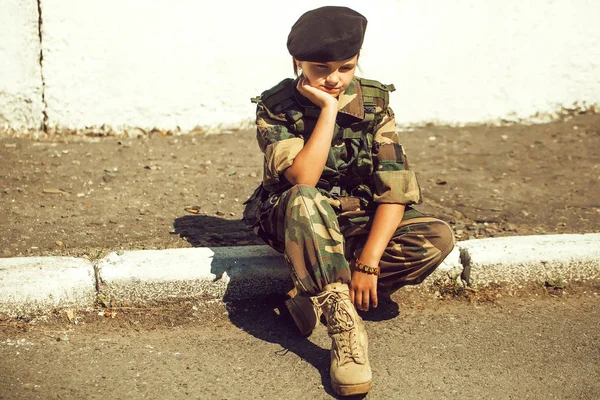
287;6;367;62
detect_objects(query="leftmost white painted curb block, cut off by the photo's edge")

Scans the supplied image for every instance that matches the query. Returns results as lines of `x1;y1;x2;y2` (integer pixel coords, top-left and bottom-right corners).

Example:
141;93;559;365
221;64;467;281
0;257;96;317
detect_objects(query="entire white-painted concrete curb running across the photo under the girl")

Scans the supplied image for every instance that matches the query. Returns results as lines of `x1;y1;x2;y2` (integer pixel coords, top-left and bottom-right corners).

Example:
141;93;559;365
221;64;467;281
0;233;600;316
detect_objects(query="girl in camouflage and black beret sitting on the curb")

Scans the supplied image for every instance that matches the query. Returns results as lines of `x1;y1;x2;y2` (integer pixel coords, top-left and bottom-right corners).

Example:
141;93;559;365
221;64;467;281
244;7;454;395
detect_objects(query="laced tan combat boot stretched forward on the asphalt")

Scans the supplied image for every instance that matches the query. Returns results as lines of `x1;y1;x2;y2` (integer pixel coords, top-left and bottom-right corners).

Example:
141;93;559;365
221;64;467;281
312;283;372;396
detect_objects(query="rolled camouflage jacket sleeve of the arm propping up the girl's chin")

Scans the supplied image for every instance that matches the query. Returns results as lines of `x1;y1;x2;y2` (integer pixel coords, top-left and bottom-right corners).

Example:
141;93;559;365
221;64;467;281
256;103;304;189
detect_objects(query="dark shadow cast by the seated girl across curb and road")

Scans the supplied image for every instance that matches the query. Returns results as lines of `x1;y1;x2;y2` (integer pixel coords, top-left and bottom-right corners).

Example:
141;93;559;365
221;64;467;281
173;215;399;398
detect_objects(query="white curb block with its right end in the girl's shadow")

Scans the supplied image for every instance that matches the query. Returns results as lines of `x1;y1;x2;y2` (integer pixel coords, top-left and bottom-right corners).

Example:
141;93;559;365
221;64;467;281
97;246;289;306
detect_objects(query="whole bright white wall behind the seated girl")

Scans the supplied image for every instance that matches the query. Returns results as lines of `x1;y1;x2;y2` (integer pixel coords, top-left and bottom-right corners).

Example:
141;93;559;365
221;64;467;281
0;0;600;135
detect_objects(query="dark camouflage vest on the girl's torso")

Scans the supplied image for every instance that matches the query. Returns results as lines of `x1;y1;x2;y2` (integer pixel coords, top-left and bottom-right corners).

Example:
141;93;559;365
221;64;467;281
252;77;395;203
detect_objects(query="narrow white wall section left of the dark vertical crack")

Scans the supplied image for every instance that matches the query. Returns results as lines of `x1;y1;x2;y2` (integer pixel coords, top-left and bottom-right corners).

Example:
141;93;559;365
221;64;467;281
0;0;44;133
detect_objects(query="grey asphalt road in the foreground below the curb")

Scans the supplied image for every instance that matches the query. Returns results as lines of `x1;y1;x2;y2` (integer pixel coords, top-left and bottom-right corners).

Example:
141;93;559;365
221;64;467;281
0;288;600;399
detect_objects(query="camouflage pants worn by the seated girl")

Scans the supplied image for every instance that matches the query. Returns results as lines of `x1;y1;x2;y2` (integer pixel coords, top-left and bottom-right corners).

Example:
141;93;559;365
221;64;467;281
261;185;454;296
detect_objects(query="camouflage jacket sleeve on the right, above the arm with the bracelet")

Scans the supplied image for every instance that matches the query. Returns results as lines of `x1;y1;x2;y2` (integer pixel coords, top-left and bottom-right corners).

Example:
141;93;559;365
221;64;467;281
373;108;422;205
